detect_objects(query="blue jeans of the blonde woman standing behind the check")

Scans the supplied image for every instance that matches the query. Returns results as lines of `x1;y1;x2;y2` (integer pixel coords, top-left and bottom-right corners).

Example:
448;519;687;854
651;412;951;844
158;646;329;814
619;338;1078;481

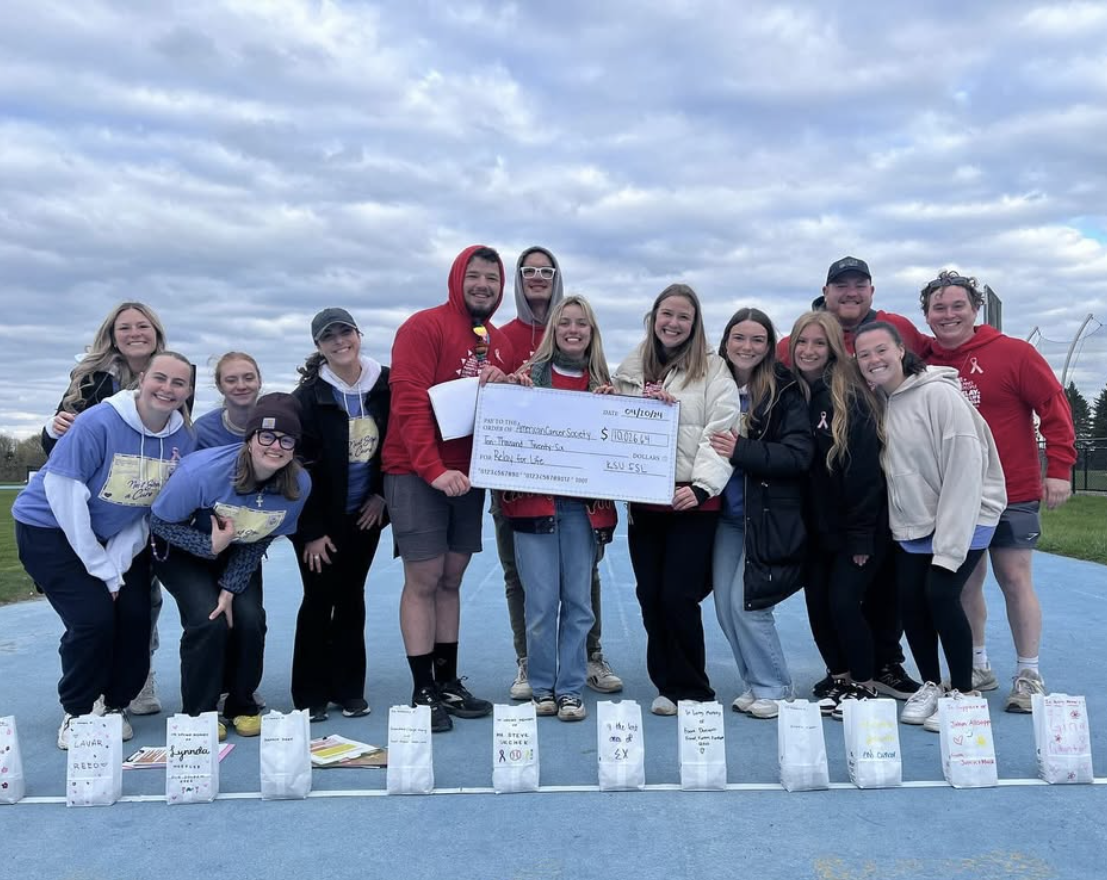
515;498;596;696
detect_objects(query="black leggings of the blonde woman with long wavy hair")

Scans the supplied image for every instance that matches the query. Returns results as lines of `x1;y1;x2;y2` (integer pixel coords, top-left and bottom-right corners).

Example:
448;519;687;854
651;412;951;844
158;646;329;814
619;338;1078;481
804;543;896;682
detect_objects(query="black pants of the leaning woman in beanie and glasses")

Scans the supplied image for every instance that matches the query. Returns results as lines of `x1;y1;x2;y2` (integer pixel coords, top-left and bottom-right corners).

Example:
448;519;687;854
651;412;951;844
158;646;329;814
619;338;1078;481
154;553;267;718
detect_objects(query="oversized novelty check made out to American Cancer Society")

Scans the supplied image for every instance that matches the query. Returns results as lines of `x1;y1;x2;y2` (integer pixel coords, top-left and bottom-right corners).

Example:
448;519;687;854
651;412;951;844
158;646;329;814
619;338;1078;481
469;384;680;504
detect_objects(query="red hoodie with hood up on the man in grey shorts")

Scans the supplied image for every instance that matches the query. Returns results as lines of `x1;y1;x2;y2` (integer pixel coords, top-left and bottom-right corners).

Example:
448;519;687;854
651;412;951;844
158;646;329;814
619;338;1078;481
381;245;515;483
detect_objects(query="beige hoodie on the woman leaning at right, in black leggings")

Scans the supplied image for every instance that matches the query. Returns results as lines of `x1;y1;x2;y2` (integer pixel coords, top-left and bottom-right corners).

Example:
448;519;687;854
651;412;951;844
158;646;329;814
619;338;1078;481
882;366;1007;571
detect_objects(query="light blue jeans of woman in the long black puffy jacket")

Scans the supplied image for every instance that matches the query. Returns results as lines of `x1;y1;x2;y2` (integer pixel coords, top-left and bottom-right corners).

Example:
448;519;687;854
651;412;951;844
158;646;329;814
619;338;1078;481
712;516;792;700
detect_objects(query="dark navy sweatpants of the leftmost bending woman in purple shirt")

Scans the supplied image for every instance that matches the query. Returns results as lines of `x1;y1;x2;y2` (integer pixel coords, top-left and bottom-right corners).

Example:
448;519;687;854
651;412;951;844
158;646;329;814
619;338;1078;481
15;521;152;715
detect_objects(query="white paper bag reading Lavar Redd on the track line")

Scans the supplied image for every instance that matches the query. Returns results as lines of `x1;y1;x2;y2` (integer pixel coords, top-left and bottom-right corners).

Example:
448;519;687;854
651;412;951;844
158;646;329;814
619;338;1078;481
65;713;123;807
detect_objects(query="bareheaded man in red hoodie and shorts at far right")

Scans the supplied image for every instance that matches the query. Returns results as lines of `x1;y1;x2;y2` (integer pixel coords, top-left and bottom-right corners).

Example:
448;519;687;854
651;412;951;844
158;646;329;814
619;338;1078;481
920;271;1076;712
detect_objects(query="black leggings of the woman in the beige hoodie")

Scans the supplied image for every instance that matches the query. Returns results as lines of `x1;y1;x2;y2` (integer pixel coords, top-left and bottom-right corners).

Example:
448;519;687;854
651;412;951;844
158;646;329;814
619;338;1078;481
896;549;984;693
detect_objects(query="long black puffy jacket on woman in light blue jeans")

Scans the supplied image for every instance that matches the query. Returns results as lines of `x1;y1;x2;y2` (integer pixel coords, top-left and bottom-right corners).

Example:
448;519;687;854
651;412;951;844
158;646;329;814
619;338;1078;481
731;366;815;611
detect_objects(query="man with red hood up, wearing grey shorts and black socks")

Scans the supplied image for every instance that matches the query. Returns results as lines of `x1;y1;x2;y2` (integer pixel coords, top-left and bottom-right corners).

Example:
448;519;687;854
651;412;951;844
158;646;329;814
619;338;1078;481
382;245;515;733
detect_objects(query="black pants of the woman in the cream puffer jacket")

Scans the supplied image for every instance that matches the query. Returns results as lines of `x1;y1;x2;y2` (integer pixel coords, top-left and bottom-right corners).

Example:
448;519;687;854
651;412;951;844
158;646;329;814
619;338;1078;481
628;507;718;703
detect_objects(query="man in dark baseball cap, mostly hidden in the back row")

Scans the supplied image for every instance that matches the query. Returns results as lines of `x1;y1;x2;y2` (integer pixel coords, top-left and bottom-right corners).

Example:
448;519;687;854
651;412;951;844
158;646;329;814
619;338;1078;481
776;257;930;700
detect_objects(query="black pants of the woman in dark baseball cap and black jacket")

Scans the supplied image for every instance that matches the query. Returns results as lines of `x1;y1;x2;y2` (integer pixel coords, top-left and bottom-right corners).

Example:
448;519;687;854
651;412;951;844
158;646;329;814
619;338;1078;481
292;514;381;708
